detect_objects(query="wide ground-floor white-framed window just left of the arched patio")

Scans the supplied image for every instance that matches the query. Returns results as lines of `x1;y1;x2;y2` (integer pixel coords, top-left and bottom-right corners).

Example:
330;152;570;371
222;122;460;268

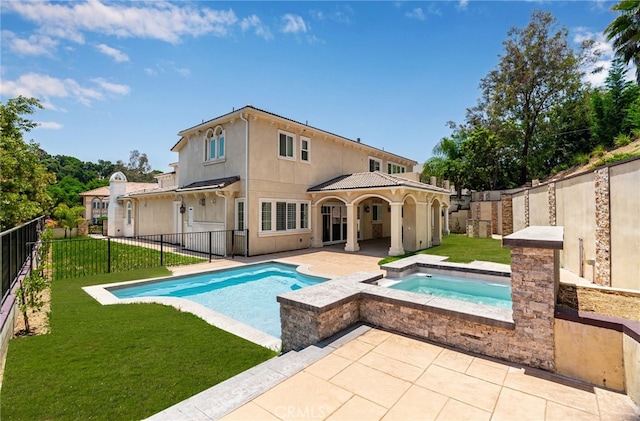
260;199;310;234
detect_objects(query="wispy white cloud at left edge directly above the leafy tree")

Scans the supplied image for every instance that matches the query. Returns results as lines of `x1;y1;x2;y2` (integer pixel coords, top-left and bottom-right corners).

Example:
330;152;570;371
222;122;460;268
0;73;129;106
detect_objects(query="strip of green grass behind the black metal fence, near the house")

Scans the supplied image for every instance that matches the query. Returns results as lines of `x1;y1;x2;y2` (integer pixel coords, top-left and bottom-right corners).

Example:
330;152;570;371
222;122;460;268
52;237;204;279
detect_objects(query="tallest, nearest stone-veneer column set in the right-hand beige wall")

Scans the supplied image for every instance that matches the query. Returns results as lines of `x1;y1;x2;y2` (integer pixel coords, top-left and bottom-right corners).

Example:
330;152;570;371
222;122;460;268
593;167;611;286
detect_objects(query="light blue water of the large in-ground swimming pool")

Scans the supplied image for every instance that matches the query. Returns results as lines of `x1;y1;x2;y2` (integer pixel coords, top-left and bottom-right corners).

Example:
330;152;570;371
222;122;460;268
110;263;325;338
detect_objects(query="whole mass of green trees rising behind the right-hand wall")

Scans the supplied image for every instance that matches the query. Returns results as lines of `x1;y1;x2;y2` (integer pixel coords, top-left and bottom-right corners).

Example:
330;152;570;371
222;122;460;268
423;11;640;190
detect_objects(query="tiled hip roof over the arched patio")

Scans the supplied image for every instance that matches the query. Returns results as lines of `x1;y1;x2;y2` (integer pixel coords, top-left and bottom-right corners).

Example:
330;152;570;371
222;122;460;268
307;171;449;193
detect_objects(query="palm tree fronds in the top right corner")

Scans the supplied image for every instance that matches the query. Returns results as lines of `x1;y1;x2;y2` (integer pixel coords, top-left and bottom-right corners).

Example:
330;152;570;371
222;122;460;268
604;0;640;85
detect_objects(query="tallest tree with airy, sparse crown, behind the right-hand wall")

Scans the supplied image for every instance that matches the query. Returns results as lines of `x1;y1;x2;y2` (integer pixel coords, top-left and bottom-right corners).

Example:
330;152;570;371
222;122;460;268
478;11;590;184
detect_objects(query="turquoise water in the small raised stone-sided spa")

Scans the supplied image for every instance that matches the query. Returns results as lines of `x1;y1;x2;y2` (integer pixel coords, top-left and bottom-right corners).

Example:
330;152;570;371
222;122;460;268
389;273;511;308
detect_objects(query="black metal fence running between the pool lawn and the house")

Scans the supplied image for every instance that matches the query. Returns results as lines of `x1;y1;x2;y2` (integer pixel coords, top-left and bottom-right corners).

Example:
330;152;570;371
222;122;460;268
45;230;249;280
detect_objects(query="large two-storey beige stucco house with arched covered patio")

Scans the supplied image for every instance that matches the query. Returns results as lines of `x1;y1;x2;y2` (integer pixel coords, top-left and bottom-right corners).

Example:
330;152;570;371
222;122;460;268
109;105;450;255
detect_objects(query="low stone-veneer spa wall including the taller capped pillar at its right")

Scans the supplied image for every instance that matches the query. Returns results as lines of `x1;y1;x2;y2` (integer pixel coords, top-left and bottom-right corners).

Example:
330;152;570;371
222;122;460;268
278;227;562;370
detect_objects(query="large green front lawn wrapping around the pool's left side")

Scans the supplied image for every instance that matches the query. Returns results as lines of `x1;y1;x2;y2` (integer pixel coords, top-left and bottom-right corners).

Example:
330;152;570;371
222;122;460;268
0;268;276;420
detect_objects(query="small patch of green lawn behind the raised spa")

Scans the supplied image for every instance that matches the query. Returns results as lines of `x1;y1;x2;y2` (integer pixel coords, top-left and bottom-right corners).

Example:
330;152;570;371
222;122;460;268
378;234;511;265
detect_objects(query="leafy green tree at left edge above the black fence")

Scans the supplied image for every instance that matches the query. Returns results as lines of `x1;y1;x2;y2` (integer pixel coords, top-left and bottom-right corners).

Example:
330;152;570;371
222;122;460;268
0;96;55;230
